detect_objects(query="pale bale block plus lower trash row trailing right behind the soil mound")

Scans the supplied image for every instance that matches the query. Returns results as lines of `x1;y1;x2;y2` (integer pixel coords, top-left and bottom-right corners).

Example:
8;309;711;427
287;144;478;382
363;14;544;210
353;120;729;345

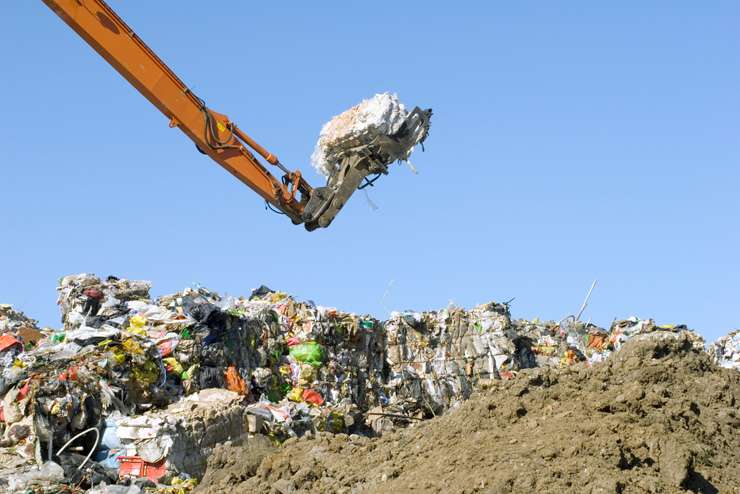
368;302;704;432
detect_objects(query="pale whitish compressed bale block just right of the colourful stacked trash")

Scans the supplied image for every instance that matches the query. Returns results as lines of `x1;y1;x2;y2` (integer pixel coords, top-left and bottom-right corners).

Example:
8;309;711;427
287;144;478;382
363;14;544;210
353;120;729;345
383;303;518;414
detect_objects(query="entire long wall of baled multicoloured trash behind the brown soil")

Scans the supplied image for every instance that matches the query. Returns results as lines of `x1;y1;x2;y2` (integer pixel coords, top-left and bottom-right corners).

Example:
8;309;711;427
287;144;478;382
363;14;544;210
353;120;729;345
0;274;738;492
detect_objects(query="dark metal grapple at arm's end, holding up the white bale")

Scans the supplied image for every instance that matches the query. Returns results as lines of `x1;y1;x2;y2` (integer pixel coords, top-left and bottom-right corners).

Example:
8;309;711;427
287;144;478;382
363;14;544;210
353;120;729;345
302;107;432;231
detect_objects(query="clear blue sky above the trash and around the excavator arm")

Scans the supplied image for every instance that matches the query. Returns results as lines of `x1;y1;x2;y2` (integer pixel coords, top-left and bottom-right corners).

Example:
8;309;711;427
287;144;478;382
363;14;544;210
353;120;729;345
0;0;740;339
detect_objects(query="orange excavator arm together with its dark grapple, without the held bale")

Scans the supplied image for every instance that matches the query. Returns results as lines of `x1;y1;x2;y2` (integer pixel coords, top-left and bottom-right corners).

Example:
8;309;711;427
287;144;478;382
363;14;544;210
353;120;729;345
43;0;431;231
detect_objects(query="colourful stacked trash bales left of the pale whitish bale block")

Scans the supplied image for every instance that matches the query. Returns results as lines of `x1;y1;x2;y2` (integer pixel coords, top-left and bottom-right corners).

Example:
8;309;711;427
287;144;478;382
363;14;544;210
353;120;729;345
0;274;385;489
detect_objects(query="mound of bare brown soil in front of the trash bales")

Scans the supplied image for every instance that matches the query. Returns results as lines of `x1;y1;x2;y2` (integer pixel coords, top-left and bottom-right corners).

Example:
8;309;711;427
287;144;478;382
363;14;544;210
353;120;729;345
197;334;740;494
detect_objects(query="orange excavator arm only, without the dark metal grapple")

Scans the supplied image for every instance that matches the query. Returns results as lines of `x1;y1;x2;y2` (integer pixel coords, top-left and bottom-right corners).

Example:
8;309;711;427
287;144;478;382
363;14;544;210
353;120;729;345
43;0;313;224
